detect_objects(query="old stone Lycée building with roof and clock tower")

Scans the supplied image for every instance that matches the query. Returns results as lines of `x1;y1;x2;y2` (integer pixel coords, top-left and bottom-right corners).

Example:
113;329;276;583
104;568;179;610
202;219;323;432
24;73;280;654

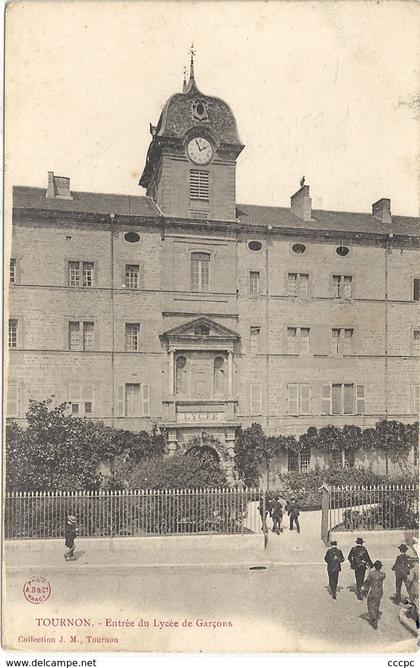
7;68;420;480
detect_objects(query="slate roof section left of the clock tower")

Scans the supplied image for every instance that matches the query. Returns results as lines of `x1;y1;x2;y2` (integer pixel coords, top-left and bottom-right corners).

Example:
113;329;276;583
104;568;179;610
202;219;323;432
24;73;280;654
13;186;161;217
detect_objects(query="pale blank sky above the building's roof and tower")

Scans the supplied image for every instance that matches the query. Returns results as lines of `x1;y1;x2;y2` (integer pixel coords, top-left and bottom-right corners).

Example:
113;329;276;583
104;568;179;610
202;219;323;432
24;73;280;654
5;0;420;215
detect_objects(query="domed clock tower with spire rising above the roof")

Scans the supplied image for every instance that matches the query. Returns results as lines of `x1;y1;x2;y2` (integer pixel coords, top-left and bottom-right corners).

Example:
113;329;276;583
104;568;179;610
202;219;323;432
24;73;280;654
140;49;244;221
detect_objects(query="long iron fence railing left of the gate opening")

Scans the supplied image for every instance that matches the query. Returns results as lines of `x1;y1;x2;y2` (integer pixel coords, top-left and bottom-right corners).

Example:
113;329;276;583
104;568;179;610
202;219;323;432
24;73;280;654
4;488;263;539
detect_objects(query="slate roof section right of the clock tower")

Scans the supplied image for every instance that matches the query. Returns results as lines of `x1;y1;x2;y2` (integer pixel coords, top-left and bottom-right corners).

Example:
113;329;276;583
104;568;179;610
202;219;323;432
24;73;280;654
237;204;420;237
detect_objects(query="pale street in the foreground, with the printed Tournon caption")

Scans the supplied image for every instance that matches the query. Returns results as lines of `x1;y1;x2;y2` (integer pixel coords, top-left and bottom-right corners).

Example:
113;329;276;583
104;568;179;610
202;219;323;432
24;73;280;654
6;552;415;652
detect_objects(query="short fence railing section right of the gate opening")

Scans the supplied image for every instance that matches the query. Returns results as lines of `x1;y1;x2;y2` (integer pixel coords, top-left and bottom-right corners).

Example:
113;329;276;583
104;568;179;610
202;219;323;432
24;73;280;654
323;484;419;531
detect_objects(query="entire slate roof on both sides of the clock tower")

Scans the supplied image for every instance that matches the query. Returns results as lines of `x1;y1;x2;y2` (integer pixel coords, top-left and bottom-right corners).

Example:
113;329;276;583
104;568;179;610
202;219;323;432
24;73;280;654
13;186;420;238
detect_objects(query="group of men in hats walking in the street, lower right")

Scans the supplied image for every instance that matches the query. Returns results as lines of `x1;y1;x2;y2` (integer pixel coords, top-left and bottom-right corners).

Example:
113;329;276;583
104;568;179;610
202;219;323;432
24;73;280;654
324;538;417;629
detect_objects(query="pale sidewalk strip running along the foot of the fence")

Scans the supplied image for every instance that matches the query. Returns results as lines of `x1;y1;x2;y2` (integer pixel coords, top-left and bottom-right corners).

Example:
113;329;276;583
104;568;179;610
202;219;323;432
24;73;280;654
4;511;414;571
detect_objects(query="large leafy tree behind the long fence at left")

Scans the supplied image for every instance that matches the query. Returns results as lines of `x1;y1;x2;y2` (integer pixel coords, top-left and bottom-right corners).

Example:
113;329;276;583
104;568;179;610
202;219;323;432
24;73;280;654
6;399;164;491
